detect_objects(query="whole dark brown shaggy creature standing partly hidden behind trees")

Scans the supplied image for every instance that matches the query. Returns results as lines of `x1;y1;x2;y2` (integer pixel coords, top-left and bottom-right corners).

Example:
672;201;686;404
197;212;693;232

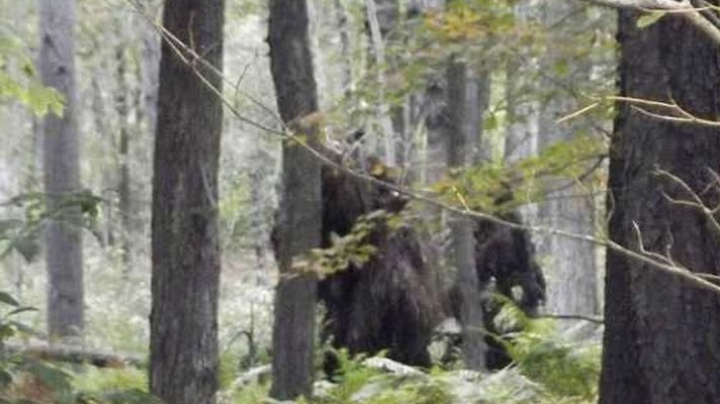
276;147;545;375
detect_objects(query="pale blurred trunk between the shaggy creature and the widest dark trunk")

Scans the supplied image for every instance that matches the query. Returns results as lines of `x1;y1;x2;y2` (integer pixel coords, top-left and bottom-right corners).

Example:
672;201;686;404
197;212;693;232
538;1;598;315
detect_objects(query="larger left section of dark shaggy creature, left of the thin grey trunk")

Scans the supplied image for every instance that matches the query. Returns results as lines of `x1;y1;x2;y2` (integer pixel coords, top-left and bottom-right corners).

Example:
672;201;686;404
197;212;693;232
319;156;441;367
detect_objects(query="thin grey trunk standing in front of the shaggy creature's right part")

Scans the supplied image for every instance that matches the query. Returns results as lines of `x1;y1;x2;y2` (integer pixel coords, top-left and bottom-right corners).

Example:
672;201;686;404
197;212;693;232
446;61;486;370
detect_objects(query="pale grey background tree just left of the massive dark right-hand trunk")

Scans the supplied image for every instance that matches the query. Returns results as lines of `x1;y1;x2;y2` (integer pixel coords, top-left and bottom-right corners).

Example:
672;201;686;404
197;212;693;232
537;2;602;322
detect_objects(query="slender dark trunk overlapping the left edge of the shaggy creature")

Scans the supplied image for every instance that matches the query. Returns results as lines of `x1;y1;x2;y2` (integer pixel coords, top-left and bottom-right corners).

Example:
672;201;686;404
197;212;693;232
269;0;322;400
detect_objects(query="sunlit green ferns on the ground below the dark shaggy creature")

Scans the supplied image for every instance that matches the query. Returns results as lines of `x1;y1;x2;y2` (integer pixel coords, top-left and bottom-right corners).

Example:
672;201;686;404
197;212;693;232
221;322;600;404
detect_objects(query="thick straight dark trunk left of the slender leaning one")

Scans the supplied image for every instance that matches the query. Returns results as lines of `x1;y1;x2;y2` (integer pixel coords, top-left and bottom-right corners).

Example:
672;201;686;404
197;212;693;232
150;0;224;404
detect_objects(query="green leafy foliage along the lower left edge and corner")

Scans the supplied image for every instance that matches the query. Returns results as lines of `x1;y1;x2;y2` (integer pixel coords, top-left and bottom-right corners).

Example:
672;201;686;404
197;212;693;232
0;210;159;404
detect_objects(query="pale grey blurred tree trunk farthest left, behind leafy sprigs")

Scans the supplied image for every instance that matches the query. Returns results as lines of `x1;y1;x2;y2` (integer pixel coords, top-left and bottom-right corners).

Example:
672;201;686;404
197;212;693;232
39;0;84;337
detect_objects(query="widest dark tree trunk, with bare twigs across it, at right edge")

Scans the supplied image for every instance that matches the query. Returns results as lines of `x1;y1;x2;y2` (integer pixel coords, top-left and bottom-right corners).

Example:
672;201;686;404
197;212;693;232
600;7;720;404
